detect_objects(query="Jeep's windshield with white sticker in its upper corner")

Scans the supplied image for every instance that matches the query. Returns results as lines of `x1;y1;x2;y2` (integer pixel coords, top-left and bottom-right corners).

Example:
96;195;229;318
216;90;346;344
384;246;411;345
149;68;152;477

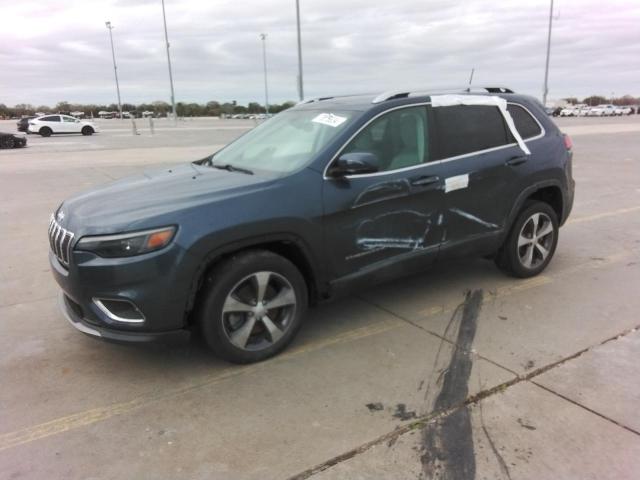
211;110;355;173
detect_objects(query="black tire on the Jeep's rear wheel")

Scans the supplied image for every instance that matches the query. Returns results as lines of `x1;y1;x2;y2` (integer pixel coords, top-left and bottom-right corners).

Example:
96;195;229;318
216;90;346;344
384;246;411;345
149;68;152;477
495;200;559;278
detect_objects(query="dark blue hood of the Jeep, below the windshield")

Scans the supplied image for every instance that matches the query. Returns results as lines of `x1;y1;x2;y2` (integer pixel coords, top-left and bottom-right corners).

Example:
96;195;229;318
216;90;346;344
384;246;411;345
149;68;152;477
57;164;278;234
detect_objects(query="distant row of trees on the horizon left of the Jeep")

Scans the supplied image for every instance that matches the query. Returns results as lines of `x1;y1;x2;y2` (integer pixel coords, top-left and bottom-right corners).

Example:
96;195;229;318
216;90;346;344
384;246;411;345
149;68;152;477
0;101;295;118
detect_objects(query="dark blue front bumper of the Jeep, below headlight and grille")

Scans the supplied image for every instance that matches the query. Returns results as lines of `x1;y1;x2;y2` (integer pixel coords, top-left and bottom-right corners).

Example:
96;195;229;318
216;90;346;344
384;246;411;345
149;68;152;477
49;240;198;342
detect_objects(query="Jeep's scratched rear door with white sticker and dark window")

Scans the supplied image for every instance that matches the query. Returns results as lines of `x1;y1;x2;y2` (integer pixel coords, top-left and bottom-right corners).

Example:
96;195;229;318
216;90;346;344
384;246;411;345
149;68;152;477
430;105;530;253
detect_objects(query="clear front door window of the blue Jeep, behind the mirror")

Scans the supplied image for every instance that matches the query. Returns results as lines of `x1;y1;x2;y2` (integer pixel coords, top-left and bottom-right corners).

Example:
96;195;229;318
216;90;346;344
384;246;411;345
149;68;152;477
342;107;429;171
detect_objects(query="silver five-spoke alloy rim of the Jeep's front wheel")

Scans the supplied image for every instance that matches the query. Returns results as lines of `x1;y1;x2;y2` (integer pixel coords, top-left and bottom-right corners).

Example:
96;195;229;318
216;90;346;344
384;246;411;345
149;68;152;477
222;271;297;351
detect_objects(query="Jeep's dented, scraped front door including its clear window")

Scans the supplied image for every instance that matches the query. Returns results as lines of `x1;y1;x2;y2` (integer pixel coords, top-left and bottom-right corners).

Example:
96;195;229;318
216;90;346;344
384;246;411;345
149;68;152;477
323;106;443;280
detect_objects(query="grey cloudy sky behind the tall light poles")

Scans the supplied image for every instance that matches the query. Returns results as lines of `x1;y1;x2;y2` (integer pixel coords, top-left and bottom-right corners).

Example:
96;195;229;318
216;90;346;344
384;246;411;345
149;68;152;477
0;0;640;105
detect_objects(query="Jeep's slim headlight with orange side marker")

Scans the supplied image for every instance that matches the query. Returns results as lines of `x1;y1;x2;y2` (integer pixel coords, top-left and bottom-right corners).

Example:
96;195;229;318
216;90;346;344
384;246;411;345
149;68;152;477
76;227;176;258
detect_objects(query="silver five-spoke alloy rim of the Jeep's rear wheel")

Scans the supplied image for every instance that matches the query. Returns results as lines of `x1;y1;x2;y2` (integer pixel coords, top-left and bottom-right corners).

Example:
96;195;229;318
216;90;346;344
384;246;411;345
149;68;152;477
518;213;555;269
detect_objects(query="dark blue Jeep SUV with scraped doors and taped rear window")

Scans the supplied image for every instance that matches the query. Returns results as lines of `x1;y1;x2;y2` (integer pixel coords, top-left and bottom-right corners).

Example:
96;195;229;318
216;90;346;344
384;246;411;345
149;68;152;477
49;88;574;362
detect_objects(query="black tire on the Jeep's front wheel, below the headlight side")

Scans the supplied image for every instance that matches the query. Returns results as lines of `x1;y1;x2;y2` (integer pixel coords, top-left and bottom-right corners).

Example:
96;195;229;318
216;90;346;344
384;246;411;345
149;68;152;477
196;250;308;363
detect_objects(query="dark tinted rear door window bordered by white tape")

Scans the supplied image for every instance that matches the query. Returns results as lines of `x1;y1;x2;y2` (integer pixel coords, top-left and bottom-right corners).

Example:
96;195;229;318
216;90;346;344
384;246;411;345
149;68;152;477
432;105;509;159
